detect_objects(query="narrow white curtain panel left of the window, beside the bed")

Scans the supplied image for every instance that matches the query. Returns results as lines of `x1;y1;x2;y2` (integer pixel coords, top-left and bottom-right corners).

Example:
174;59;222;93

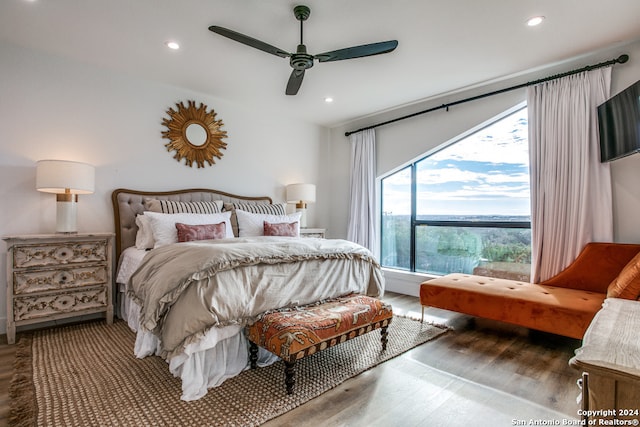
347;129;378;254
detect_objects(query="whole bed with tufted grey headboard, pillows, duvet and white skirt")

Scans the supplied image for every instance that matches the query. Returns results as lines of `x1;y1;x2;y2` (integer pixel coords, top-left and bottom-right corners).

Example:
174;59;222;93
112;189;384;400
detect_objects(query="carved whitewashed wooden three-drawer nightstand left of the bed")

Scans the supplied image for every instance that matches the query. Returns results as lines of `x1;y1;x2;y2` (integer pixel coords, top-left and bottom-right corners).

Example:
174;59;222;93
4;233;113;344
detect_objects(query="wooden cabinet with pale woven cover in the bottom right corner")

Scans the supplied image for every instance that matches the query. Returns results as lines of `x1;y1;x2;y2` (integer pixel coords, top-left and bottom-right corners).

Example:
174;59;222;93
569;298;640;425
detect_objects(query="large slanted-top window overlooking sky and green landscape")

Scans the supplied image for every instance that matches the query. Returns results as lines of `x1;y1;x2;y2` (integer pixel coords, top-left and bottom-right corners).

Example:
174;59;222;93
381;108;531;280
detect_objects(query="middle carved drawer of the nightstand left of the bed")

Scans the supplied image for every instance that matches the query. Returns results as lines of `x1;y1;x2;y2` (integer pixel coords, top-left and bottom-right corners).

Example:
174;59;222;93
13;265;108;295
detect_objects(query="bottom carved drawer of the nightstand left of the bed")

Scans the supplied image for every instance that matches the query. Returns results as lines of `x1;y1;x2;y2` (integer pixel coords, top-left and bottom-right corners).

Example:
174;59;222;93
13;286;107;321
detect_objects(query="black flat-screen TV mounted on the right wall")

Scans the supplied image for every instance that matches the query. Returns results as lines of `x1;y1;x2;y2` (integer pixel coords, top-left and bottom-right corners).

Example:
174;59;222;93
598;80;640;162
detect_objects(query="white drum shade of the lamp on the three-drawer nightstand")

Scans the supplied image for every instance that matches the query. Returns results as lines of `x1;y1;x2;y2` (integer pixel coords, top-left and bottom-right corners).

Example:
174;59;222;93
36;160;95;194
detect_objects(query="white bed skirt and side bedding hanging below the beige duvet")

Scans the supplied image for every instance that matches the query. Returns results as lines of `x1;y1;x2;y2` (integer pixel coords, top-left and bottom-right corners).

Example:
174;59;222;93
116;247;278;401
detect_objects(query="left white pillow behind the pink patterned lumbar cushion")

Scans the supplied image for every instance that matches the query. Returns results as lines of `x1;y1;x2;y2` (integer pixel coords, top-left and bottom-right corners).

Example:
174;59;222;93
145;212;233;248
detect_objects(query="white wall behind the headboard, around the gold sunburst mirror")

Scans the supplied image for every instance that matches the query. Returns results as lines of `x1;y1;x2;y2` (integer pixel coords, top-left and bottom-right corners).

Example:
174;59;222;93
0;44;328;333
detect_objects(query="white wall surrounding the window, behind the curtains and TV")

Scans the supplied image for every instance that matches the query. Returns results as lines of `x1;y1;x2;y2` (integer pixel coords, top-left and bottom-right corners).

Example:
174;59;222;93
328;42;640;295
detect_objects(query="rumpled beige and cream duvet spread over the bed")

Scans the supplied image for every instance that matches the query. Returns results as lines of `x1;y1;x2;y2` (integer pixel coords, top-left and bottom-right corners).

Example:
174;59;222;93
128;237;384;360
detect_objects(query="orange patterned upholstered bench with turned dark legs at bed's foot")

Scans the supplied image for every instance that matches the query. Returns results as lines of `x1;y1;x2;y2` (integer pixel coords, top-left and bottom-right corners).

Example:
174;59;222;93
246;294;393;394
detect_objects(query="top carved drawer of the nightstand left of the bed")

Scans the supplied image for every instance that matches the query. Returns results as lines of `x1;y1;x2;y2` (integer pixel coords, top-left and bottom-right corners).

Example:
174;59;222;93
13;240;107;268
